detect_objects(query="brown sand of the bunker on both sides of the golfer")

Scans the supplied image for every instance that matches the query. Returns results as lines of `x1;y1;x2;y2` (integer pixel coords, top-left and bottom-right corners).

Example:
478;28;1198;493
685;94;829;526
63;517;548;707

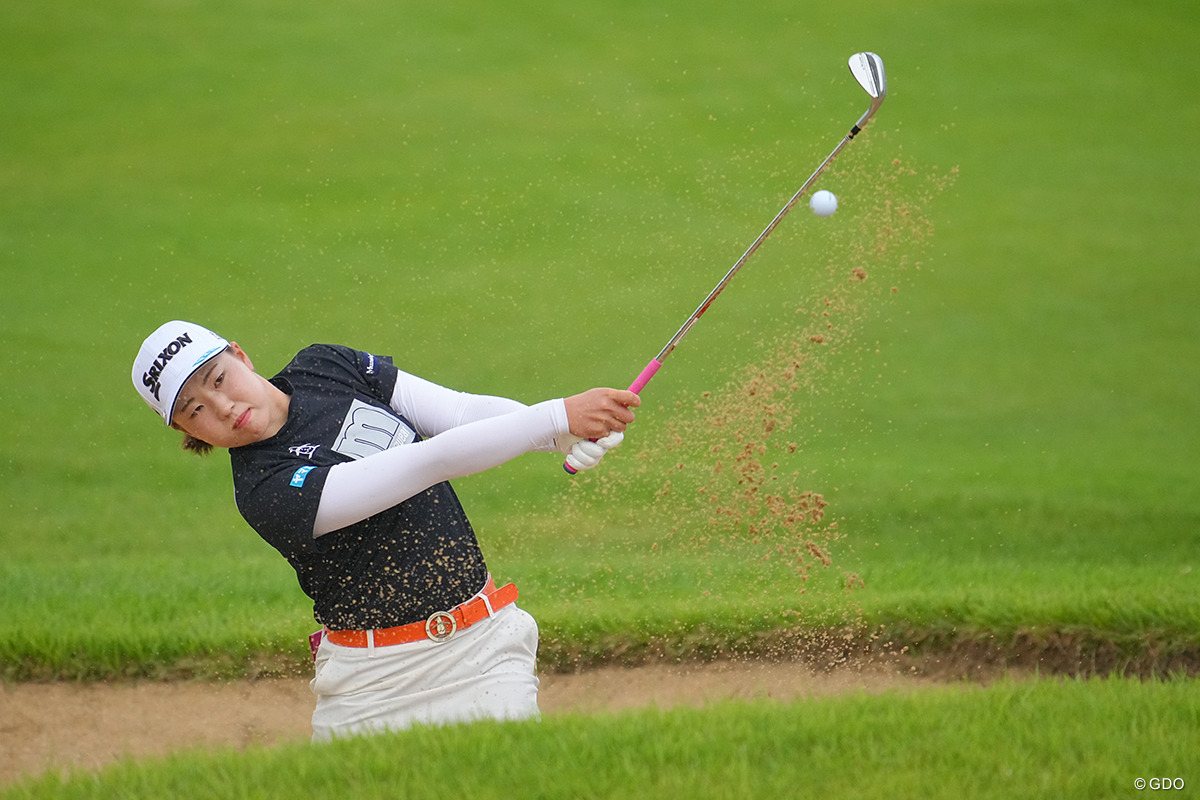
0;633;1200;787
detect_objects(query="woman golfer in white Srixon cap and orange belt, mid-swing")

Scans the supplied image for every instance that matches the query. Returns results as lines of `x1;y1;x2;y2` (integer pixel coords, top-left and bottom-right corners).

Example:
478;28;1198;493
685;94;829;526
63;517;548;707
133;320;641;741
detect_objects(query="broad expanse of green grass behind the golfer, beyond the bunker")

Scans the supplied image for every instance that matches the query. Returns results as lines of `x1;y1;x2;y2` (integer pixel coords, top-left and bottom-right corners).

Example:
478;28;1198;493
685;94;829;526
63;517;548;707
0;0;1200;675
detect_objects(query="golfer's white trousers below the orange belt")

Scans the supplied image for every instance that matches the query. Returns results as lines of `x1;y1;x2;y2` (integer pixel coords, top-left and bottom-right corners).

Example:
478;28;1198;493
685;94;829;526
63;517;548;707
311;603;539;741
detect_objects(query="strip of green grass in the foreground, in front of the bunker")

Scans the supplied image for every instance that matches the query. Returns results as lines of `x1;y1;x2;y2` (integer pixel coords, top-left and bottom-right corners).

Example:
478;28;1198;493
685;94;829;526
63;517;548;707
0;680;1200;800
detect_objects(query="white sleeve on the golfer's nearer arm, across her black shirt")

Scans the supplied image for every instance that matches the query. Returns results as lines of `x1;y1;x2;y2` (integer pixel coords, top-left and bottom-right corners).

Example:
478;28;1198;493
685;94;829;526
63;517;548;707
313;390;570;536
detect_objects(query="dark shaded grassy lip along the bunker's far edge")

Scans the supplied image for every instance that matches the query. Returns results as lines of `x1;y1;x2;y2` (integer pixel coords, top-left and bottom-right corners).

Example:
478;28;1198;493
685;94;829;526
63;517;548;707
0;625;1200;682
